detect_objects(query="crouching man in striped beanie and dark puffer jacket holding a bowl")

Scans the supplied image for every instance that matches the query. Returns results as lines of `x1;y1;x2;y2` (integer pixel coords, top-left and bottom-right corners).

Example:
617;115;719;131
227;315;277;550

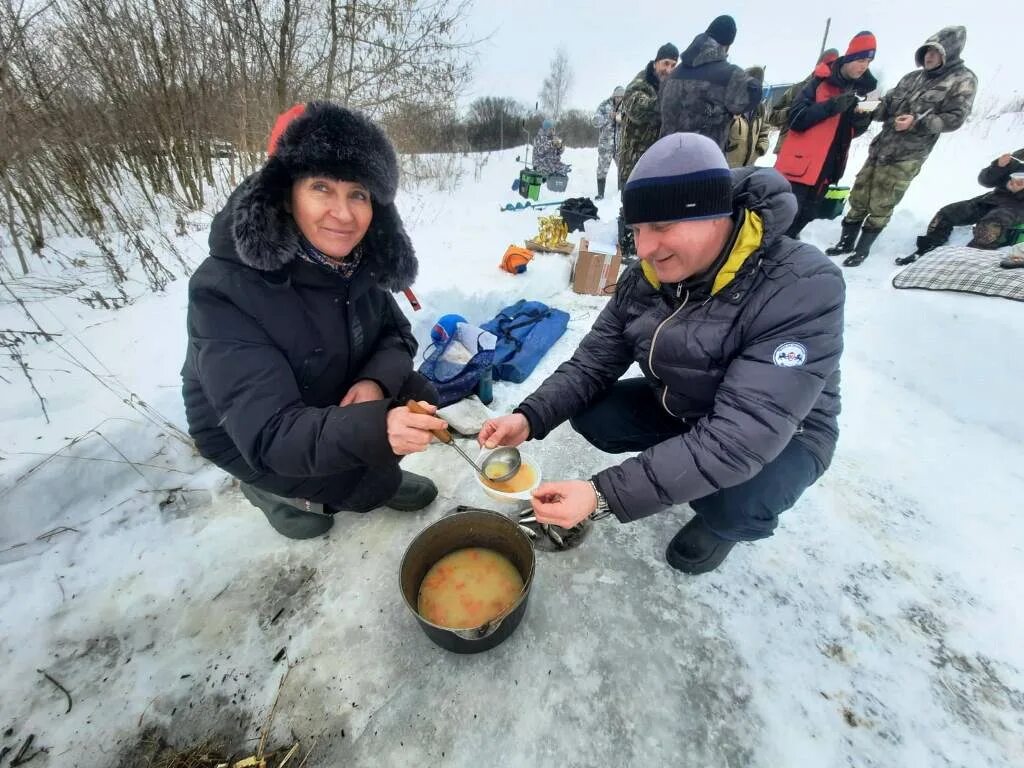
480;133;846;573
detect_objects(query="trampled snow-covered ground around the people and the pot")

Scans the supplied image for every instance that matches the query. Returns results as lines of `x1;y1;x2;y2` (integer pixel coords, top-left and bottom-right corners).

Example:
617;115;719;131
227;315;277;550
0;116;1024;768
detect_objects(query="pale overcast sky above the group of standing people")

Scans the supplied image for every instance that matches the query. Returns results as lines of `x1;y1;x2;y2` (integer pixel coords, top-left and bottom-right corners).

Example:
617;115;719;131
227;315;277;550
463;0;1024;115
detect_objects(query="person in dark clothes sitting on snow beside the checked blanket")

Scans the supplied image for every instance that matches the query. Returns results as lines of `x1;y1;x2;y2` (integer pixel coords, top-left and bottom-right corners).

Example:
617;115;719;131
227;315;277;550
896;147;1024;266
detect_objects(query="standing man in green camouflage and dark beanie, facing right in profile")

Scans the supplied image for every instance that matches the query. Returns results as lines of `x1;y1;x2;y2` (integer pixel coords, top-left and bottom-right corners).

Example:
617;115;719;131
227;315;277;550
618;43;679;189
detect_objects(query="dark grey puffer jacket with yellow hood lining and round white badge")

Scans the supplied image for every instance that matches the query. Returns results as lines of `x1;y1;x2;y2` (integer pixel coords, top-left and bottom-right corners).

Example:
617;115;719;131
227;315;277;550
519;168;846;521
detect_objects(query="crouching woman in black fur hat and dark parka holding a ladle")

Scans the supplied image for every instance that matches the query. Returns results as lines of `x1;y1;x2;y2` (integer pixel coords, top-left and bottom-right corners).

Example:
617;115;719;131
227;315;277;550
181;101;444;539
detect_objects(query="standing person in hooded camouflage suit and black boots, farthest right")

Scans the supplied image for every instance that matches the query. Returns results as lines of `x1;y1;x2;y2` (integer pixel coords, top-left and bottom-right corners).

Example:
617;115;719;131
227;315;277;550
825;27;978;266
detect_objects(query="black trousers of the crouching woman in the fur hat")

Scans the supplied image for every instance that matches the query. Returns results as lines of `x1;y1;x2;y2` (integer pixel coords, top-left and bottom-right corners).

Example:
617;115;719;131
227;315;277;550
218;372;439;512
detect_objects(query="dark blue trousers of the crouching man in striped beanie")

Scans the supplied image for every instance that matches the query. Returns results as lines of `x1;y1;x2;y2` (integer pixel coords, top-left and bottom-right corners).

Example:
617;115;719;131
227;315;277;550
571;379;824;542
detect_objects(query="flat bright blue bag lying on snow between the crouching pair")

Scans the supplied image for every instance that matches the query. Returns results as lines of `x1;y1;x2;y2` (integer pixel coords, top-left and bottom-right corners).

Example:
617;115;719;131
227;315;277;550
480;299;569;384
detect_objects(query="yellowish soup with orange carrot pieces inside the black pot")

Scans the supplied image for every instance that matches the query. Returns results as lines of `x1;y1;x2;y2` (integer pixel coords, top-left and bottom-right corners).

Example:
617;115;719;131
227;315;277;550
417;547;523;630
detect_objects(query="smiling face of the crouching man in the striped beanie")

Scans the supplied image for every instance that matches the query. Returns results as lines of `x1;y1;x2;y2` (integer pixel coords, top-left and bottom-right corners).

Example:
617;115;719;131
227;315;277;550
633;216;732;283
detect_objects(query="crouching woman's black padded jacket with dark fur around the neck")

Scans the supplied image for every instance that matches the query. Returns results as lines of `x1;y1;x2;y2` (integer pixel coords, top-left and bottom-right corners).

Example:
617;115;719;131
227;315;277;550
181;178;416;477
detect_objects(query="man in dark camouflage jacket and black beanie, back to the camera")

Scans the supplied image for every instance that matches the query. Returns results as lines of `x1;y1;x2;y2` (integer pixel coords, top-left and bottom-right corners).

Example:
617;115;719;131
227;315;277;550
662;16;762;151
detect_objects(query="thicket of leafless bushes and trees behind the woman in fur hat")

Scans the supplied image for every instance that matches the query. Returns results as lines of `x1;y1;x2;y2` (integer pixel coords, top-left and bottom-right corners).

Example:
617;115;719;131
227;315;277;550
0;0;470;290
